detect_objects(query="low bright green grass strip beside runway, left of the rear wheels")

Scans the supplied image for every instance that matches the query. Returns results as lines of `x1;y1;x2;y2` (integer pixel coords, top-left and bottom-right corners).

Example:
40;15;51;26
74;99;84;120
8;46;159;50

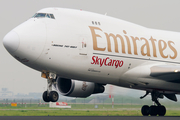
0;110;141;116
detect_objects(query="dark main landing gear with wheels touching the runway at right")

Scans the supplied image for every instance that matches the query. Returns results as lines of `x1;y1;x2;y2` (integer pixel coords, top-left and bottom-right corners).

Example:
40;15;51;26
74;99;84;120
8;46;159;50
140;91;166;116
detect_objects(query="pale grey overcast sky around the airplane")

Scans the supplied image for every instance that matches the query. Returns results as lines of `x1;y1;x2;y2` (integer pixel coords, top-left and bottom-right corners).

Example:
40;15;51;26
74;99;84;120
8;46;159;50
0;0;180;97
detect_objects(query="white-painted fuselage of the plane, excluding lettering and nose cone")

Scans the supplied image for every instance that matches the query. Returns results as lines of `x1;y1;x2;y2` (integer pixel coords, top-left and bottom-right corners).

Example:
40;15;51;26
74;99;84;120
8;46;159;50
4;8;180;93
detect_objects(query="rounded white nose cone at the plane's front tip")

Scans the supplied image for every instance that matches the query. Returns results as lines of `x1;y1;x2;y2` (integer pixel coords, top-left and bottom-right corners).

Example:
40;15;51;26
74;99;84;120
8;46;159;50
3;31;20;53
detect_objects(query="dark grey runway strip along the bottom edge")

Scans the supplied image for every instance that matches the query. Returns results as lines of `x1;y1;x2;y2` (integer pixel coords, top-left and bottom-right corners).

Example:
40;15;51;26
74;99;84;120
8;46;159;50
0;116;180;120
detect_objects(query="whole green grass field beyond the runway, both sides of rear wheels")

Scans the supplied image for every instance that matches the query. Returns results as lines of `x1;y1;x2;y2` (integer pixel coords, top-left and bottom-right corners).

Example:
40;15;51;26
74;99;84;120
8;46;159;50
0;104;180;116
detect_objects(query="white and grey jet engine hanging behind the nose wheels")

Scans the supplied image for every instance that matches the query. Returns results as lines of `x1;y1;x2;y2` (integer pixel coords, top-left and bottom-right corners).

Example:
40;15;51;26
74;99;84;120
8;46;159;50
55;78;105;98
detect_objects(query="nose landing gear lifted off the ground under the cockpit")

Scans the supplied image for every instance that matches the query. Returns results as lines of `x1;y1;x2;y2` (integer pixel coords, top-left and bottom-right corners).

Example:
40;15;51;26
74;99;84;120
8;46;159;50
42;73;59;102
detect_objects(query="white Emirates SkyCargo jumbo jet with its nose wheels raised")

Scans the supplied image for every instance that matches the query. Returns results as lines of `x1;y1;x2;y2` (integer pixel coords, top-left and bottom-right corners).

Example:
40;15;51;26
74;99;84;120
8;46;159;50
3;8;180;116
